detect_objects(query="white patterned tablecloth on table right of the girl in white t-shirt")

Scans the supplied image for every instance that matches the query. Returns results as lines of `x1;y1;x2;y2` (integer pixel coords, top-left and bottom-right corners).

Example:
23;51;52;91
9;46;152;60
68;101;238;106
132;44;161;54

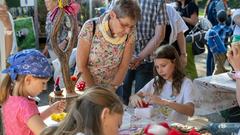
193;73;237;115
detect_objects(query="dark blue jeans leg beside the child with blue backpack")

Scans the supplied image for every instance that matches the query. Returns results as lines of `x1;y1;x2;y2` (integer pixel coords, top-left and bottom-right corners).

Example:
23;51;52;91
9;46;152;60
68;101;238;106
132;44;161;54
206;46;214;76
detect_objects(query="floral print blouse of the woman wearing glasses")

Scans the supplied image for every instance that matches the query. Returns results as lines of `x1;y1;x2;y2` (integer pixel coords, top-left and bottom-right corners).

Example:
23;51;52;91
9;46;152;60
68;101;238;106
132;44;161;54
78;18;134;87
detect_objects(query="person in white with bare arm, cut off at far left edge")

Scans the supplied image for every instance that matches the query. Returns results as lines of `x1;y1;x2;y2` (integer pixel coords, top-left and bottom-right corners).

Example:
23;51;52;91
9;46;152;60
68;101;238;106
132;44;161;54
0;5;17;82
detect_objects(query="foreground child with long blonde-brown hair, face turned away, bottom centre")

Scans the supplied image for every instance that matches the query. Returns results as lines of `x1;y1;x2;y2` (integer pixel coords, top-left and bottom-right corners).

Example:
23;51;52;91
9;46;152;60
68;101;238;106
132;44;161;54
41;87;123;135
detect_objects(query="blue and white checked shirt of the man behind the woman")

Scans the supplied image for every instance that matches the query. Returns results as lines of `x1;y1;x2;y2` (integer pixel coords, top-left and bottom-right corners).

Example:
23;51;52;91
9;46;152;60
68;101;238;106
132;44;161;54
135;0;169;62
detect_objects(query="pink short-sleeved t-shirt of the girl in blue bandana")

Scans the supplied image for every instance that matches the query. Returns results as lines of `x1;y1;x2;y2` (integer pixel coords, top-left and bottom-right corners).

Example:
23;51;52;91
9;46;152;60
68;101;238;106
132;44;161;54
2;96;39;135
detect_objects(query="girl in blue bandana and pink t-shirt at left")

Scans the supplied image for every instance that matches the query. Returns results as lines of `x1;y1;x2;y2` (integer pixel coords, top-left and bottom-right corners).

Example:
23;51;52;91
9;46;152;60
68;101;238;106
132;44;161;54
0;49;65;135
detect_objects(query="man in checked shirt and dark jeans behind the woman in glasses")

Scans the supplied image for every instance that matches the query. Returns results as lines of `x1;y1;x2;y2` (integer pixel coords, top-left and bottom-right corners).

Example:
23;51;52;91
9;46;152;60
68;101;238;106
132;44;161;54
123;0;169;104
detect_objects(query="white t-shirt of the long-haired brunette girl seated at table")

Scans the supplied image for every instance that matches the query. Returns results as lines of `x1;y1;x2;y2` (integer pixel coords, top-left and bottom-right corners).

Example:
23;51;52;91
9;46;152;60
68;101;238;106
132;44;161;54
139;78;193;124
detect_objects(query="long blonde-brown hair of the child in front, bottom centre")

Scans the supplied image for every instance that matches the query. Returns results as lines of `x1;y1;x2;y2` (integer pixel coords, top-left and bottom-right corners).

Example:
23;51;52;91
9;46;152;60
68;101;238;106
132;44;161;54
42;87;123;135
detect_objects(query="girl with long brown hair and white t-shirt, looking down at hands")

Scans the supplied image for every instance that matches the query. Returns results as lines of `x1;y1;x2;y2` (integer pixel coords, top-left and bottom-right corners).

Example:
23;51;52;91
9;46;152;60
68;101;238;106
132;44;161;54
130;45;194;124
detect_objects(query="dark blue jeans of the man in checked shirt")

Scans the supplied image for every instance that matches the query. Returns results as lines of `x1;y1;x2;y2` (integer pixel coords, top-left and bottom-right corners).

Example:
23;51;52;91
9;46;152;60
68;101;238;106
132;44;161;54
123;62;153;105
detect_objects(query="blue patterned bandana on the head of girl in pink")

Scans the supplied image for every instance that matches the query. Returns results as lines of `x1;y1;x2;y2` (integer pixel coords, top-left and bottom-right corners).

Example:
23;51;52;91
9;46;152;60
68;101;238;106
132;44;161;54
2;49;52;80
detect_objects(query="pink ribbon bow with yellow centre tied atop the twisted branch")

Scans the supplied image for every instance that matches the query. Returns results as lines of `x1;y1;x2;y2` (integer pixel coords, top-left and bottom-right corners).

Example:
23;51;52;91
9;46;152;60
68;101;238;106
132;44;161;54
50;0;80;22
